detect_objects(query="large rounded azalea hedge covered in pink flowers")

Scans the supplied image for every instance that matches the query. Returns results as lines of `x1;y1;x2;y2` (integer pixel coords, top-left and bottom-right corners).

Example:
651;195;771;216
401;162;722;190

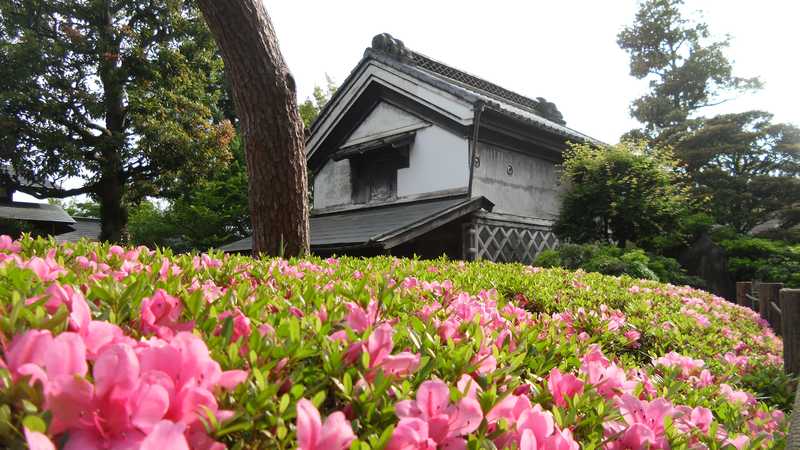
0;237;792;450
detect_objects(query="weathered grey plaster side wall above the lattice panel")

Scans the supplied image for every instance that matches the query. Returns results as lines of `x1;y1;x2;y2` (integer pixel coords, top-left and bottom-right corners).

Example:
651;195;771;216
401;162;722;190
472;143;561;220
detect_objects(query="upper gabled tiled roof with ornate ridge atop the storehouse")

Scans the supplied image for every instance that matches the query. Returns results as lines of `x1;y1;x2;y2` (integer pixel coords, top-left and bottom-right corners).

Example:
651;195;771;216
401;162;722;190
308;33;602;162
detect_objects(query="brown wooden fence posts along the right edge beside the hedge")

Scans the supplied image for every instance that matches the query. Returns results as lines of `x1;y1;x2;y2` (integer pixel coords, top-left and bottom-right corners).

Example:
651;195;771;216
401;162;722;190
736;281;800;450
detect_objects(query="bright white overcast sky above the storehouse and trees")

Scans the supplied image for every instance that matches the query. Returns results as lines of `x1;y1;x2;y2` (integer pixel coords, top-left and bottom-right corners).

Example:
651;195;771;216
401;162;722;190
14;0;800;202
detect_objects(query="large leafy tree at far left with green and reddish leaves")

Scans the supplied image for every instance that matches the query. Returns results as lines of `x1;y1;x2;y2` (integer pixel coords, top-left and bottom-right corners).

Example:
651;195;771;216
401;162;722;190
0;0;234;241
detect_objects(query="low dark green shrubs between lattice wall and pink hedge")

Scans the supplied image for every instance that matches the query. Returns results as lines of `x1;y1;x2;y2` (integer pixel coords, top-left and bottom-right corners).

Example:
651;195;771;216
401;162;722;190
533;243;702;286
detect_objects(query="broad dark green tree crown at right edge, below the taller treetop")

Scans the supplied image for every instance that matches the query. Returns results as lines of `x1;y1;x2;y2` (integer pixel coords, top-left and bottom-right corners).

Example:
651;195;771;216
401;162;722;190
670;111;800;233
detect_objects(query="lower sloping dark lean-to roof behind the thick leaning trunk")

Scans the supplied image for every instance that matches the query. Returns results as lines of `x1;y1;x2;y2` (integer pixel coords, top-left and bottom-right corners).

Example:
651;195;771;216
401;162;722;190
220;197;488;252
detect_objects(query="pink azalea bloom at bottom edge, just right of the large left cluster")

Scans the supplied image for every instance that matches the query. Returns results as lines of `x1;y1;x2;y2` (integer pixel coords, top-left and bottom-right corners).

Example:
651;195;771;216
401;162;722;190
297;398;355;450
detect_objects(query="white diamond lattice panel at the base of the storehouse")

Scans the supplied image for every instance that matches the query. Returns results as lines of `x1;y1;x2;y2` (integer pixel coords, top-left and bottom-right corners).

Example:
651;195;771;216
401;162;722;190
473;223;558;264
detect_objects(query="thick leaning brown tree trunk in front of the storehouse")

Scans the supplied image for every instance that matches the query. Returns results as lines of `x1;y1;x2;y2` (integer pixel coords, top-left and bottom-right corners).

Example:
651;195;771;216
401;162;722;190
199;0;309;256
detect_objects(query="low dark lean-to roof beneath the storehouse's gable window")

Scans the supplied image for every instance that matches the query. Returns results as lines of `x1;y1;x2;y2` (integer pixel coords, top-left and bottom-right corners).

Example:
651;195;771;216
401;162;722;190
220;196;494;252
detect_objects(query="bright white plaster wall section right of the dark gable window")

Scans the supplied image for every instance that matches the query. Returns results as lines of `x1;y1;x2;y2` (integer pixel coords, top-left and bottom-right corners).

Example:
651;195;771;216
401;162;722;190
397;125;469;197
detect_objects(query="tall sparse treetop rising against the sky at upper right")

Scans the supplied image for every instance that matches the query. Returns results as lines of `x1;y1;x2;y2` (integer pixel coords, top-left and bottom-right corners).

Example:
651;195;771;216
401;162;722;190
617;0;761;136
